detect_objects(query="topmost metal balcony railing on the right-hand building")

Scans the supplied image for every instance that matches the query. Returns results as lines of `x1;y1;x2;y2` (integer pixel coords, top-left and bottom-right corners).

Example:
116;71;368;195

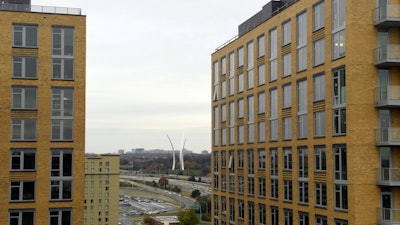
374;5;400;27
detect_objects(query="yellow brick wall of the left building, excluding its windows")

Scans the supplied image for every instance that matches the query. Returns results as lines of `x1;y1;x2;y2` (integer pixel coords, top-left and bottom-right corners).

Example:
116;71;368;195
0;4;86;224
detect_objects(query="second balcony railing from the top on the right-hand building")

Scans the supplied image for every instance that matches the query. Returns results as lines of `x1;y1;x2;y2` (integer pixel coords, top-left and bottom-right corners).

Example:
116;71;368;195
374;44;400;67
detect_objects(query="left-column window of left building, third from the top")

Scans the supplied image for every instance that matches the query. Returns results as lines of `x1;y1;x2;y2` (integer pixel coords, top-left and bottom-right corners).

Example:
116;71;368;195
12;86;37;109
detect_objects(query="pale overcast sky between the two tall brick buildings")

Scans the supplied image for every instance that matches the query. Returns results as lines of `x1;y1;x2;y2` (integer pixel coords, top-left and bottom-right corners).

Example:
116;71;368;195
32;0;268;153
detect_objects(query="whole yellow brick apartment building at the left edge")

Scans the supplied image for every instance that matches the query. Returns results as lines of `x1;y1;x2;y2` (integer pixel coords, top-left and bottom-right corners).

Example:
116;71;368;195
0;0;86;225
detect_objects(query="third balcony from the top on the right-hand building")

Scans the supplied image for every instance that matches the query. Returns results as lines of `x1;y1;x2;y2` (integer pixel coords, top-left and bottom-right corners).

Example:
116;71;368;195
375;86;400;108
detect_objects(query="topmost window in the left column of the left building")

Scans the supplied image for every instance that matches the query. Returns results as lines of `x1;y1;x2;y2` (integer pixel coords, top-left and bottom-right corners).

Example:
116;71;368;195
13;24;38;48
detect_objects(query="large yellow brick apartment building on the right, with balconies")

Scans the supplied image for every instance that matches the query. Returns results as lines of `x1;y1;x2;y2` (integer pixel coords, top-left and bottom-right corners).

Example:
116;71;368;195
212;0;400;225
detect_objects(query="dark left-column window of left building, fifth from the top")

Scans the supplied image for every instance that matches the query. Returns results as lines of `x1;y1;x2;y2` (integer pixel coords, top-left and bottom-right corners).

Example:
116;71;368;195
11;148;36;171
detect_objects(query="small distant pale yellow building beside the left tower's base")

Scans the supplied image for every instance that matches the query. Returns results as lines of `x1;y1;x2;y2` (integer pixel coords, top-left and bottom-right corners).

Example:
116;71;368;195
83;154;120;225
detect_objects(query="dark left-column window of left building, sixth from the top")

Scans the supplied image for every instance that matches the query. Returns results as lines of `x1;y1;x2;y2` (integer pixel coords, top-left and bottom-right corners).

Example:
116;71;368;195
10;181;35;201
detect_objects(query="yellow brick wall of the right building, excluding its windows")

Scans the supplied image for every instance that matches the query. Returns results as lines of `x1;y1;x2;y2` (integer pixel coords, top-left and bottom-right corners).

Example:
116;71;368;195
211;0;400;225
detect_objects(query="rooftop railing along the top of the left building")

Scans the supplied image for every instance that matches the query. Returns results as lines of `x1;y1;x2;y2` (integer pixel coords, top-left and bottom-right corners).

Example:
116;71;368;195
0;3;81;15
